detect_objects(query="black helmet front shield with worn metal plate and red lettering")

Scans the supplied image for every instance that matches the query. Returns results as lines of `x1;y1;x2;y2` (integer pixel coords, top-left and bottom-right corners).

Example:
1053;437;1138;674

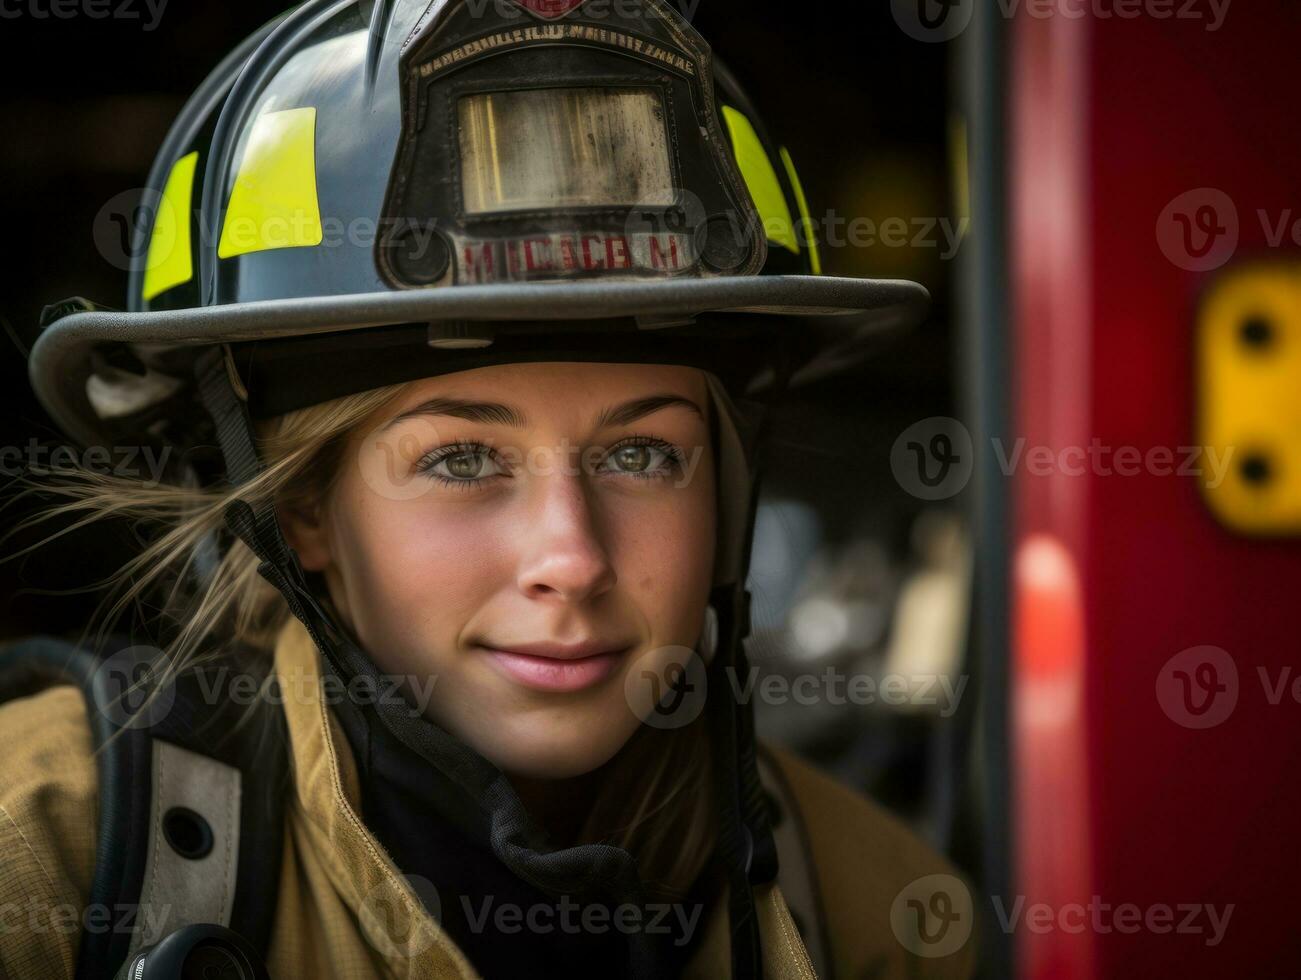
379;3;759;286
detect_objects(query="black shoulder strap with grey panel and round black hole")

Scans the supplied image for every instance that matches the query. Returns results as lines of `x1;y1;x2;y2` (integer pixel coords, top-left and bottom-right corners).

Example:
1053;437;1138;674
0;636;289;980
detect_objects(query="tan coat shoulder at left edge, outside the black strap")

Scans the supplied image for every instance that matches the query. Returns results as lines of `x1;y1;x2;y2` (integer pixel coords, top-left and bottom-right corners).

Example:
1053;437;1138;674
0;685;98;977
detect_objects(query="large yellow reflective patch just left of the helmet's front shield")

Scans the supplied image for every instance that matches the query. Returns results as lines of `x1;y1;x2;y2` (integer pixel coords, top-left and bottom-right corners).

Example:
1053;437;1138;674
217;107;325;259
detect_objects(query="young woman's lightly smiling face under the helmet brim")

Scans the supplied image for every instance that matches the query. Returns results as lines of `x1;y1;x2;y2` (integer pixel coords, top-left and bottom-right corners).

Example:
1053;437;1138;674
286;363;716;778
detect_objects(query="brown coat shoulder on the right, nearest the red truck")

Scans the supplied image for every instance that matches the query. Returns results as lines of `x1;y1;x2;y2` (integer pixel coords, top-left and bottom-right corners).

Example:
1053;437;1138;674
760;742;978;980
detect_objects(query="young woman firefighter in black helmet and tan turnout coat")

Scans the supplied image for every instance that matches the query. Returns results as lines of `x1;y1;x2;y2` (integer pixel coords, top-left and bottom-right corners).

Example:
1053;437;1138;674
0;0;974;977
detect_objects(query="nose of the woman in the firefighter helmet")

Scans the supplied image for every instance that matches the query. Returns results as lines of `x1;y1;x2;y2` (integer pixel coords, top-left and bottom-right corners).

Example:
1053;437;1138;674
519;475;617;603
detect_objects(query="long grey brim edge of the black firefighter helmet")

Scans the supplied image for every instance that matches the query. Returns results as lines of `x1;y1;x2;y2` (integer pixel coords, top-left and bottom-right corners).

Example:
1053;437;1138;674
29;276;930;445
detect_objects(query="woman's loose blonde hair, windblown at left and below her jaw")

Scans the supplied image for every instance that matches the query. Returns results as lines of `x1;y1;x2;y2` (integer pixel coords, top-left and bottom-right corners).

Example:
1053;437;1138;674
9;385;717;901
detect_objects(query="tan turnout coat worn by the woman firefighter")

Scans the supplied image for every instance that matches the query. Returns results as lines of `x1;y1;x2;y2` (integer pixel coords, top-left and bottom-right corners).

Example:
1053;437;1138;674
0;621;976;980
